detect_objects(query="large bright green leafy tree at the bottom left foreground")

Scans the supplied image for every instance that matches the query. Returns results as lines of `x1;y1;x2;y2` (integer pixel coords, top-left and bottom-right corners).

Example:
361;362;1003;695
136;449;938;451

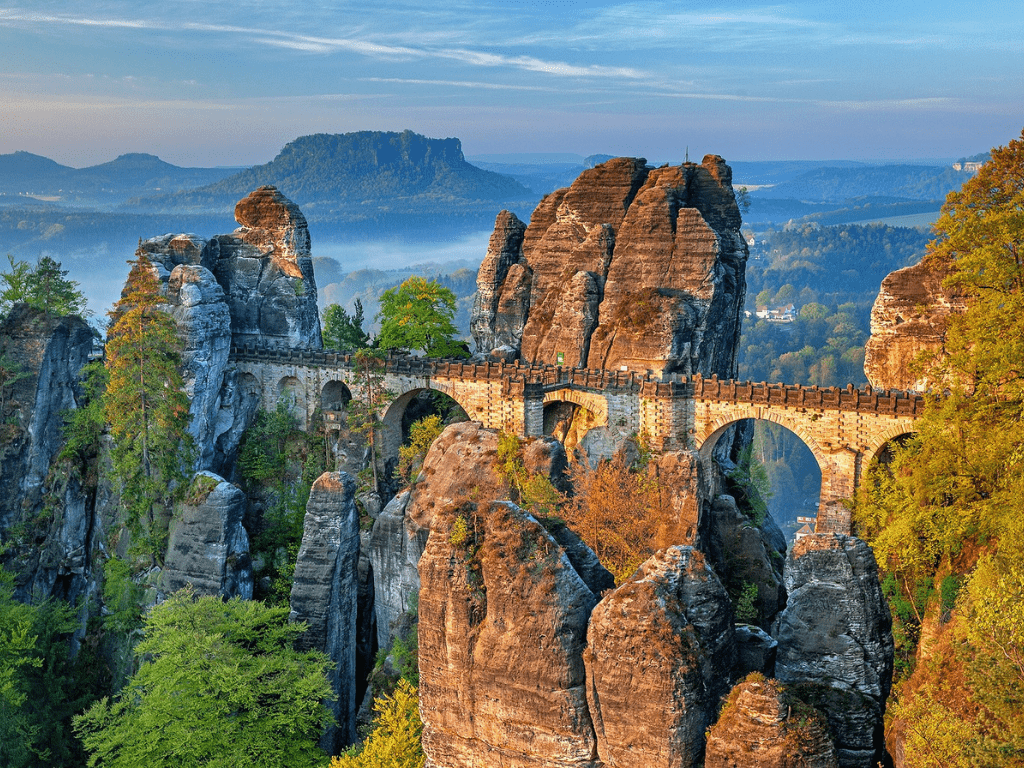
75;590;331;768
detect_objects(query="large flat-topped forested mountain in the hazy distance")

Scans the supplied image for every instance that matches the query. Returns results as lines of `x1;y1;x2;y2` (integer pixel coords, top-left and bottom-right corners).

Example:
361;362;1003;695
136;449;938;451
127;130;538;221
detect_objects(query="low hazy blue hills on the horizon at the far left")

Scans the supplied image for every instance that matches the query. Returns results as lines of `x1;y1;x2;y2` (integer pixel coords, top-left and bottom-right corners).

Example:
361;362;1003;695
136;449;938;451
0;152;233;206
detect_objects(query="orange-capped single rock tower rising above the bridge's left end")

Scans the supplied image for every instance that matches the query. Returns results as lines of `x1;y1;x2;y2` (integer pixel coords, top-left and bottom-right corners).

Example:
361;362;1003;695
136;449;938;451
210;186;324;349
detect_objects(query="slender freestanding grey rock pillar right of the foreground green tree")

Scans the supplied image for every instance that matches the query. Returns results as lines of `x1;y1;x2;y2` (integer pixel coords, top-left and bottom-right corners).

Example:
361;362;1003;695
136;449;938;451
289;472;359;754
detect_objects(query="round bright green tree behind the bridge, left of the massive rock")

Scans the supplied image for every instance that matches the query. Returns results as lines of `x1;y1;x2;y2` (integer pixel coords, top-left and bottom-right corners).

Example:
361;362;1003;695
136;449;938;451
377;278;467;357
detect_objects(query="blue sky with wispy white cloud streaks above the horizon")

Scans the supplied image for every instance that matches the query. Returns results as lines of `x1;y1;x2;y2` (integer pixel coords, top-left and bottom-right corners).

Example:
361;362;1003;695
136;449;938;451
0;0;1024;166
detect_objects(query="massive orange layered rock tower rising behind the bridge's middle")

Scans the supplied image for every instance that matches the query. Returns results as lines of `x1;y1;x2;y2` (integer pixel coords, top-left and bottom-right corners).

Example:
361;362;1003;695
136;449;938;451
471;155;748;377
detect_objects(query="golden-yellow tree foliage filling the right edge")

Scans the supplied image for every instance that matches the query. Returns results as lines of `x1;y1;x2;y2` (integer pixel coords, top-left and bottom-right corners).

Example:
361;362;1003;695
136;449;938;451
856;129;1024;768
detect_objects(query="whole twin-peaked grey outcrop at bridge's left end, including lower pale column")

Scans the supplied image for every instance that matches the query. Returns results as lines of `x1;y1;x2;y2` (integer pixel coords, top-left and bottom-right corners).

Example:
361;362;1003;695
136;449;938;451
139;186;323;473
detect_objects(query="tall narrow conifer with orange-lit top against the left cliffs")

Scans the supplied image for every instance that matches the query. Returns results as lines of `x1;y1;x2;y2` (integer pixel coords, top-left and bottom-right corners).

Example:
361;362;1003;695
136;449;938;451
103;249;195;557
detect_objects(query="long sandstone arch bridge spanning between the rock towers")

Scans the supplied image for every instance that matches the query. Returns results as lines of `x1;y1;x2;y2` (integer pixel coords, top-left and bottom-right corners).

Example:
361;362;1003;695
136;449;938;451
231;346;925;532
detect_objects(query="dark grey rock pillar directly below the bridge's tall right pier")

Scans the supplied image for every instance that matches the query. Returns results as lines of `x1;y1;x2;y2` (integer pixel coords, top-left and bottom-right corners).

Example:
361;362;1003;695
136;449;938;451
773;534;893;768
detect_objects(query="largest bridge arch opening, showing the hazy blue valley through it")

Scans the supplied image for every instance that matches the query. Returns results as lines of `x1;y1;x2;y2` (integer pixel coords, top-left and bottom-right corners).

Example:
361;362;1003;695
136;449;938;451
700;419;822;545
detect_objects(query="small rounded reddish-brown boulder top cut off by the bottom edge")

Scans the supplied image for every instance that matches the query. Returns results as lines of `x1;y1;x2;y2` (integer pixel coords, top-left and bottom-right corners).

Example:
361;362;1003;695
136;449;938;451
705;680;839;768
